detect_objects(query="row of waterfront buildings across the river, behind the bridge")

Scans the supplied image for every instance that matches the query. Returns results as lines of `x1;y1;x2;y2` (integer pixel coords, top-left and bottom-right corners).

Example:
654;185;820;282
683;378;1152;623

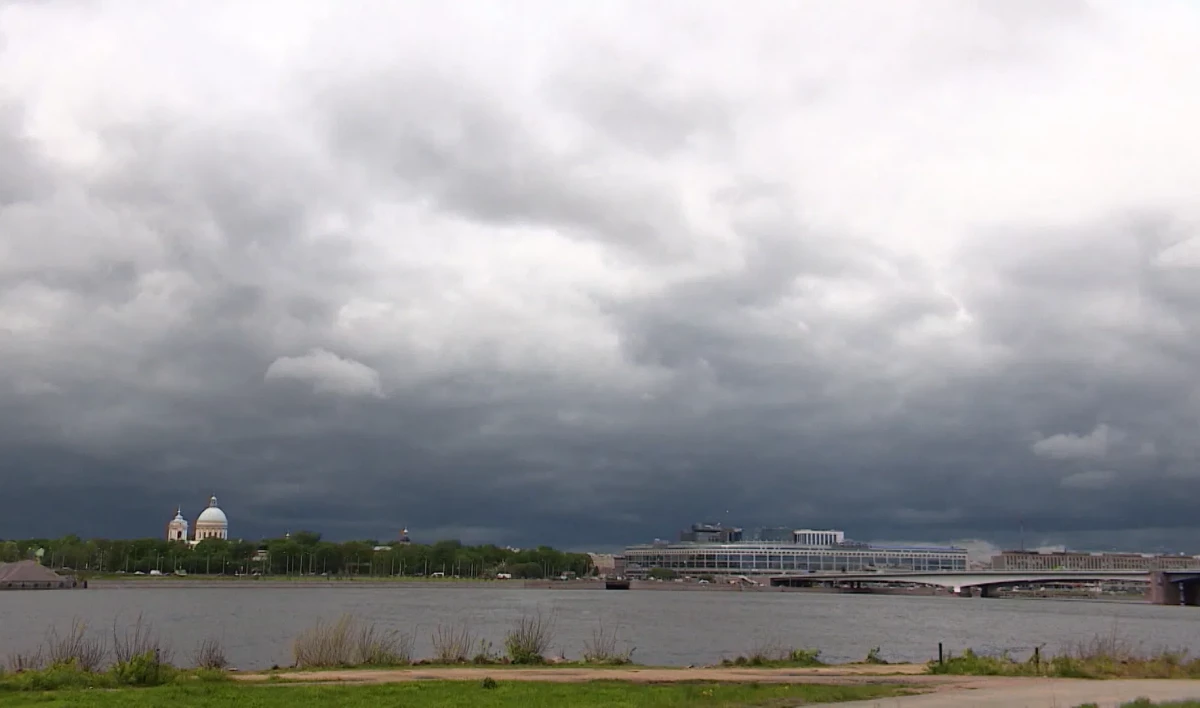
610;523;1200;578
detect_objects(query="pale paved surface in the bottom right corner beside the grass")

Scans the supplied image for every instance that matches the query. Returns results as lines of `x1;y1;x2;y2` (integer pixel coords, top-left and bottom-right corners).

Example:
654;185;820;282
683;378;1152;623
829;678;1200;708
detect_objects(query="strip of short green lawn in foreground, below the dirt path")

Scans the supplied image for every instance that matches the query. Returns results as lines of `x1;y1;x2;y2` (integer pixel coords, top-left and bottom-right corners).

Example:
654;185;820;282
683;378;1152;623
0;677;910;708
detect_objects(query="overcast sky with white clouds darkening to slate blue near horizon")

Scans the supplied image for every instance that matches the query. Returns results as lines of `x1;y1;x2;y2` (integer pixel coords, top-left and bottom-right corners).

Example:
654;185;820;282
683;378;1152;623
0;0;1200;552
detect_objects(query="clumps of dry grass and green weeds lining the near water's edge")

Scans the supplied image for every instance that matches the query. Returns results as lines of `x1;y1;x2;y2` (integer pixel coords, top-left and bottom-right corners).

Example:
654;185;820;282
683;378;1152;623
9;613;1200;691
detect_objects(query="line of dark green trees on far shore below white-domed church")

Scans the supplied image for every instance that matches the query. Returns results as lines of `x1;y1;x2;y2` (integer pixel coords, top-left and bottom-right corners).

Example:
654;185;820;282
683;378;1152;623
0;532;593;578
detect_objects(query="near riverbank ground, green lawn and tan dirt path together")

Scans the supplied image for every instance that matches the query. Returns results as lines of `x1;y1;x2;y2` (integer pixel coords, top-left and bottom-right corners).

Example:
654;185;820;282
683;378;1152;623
0;665;1200;708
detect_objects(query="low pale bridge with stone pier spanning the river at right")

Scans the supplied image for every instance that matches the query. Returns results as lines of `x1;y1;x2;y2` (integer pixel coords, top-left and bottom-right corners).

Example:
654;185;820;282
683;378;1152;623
770;569;1200;605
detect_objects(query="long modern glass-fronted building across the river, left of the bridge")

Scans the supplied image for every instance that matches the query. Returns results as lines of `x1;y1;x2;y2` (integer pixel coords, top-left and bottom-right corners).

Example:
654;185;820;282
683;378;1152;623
625;532;967;578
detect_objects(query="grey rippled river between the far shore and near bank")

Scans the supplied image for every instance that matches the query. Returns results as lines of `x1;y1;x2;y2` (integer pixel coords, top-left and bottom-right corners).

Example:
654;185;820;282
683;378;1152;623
0;584;1200;670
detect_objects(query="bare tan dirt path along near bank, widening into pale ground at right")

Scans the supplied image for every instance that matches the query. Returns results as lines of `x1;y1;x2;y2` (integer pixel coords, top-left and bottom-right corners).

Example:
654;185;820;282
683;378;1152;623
235;664;1200;708
